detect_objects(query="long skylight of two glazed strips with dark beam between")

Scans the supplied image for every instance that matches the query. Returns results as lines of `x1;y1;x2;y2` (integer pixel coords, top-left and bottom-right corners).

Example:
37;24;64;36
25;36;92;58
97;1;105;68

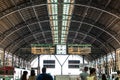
48;0;74;44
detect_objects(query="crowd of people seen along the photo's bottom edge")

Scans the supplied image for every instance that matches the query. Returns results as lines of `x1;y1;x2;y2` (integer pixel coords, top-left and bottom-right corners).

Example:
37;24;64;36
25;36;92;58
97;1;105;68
20;67;120;80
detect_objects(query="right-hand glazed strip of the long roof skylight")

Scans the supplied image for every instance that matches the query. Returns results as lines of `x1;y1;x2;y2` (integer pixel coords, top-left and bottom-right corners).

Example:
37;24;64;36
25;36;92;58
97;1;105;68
61;0;74;43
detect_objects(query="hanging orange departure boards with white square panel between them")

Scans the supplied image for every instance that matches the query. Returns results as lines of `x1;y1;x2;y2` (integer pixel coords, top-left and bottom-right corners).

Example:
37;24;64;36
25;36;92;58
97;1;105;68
31;44;91;55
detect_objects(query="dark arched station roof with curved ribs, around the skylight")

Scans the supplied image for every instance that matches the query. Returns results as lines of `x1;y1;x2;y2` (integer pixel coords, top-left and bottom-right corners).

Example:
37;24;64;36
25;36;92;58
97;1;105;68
0;0;120;61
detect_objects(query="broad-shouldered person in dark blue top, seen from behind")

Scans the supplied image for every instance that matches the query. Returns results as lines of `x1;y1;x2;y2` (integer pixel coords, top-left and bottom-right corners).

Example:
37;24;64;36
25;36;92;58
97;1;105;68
36;67;53;80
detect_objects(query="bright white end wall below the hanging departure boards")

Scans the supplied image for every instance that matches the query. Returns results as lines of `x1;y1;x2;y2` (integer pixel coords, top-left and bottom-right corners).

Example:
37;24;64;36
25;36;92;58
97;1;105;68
31;55;87;75
